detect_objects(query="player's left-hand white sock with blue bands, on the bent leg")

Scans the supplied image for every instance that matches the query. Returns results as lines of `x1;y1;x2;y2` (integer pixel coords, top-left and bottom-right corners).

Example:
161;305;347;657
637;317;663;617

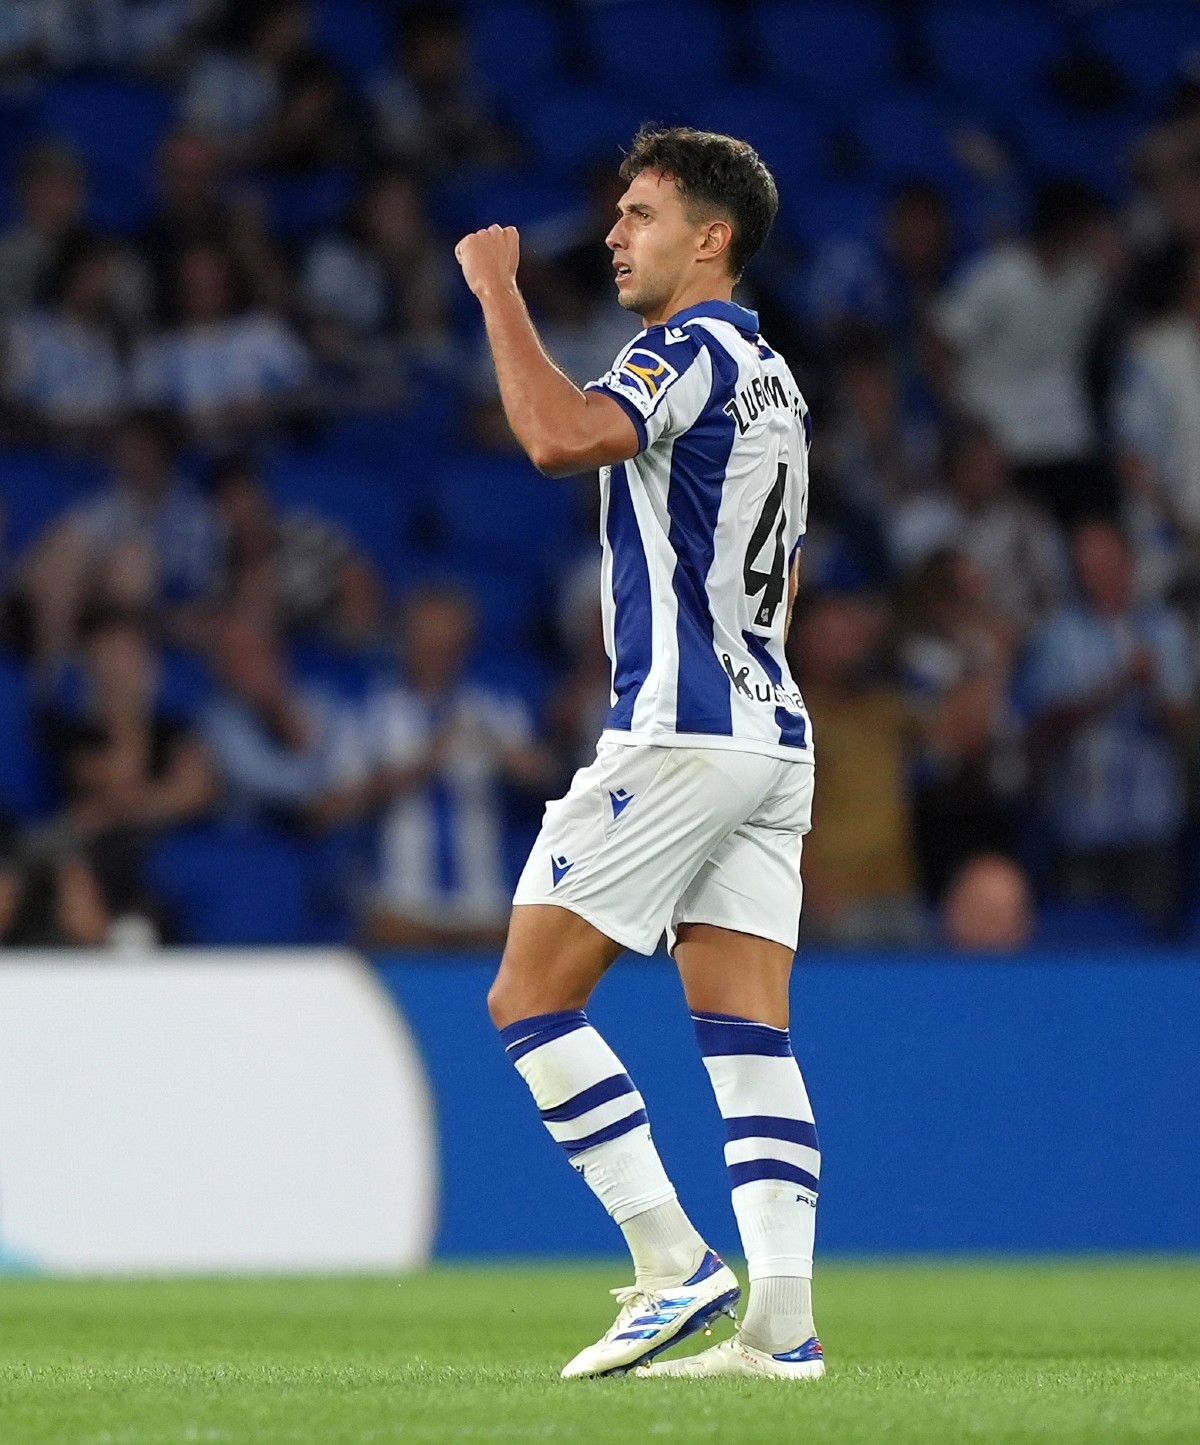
500;1010;706;1286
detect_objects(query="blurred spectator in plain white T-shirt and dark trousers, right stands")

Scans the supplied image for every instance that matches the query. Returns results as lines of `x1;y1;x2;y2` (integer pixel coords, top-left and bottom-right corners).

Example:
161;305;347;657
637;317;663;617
933;181;1116;525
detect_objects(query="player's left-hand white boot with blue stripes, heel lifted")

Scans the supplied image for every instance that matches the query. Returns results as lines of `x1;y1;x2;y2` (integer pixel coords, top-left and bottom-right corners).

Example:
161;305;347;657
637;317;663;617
562;1250;742;1380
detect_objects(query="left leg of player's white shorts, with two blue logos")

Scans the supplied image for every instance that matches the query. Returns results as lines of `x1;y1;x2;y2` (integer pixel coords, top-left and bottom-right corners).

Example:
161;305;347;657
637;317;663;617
516;744;772;954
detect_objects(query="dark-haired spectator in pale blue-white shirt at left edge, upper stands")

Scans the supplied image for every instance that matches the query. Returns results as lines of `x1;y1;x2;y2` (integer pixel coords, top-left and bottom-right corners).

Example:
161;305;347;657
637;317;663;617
3;233;129;442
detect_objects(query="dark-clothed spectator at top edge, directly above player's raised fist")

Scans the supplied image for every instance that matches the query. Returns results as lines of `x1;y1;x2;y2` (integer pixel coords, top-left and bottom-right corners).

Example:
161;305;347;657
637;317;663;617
372;0;519;175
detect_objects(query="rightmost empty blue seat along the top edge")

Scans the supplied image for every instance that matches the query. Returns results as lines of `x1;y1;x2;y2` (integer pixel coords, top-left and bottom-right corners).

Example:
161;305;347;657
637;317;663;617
922;0;1067;114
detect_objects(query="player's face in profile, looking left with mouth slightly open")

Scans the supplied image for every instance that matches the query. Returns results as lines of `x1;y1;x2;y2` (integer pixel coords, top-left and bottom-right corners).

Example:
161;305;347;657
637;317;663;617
607;171;706;322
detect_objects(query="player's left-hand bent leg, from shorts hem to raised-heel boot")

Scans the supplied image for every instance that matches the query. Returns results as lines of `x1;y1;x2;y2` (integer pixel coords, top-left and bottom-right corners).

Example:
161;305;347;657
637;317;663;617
487;905;739;1376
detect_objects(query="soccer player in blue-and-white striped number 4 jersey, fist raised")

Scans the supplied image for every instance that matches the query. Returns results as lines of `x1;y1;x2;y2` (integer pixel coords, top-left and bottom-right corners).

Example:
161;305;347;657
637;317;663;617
455;129;824;1380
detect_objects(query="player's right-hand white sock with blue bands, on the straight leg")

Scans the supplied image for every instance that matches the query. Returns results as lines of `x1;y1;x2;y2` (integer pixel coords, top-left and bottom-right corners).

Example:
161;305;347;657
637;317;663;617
691;1013;821;1353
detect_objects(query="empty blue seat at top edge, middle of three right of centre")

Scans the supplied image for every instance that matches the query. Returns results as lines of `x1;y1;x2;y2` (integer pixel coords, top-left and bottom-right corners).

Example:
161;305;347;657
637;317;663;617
755;0;896;111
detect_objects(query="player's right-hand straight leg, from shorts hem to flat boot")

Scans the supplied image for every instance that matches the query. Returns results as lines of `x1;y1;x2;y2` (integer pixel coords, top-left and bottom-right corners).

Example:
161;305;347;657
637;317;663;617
648;923;824;1380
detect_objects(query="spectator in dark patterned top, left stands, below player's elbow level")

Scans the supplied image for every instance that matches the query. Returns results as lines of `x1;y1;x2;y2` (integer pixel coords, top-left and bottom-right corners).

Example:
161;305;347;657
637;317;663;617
213;458;383;647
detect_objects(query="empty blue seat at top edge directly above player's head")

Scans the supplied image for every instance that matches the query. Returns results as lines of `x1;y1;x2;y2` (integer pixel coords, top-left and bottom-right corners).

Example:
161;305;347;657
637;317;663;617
583;0;730;106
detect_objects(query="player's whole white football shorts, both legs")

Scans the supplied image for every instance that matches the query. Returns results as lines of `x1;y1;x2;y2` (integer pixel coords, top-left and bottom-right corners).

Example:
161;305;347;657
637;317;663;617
513;741;813;954
